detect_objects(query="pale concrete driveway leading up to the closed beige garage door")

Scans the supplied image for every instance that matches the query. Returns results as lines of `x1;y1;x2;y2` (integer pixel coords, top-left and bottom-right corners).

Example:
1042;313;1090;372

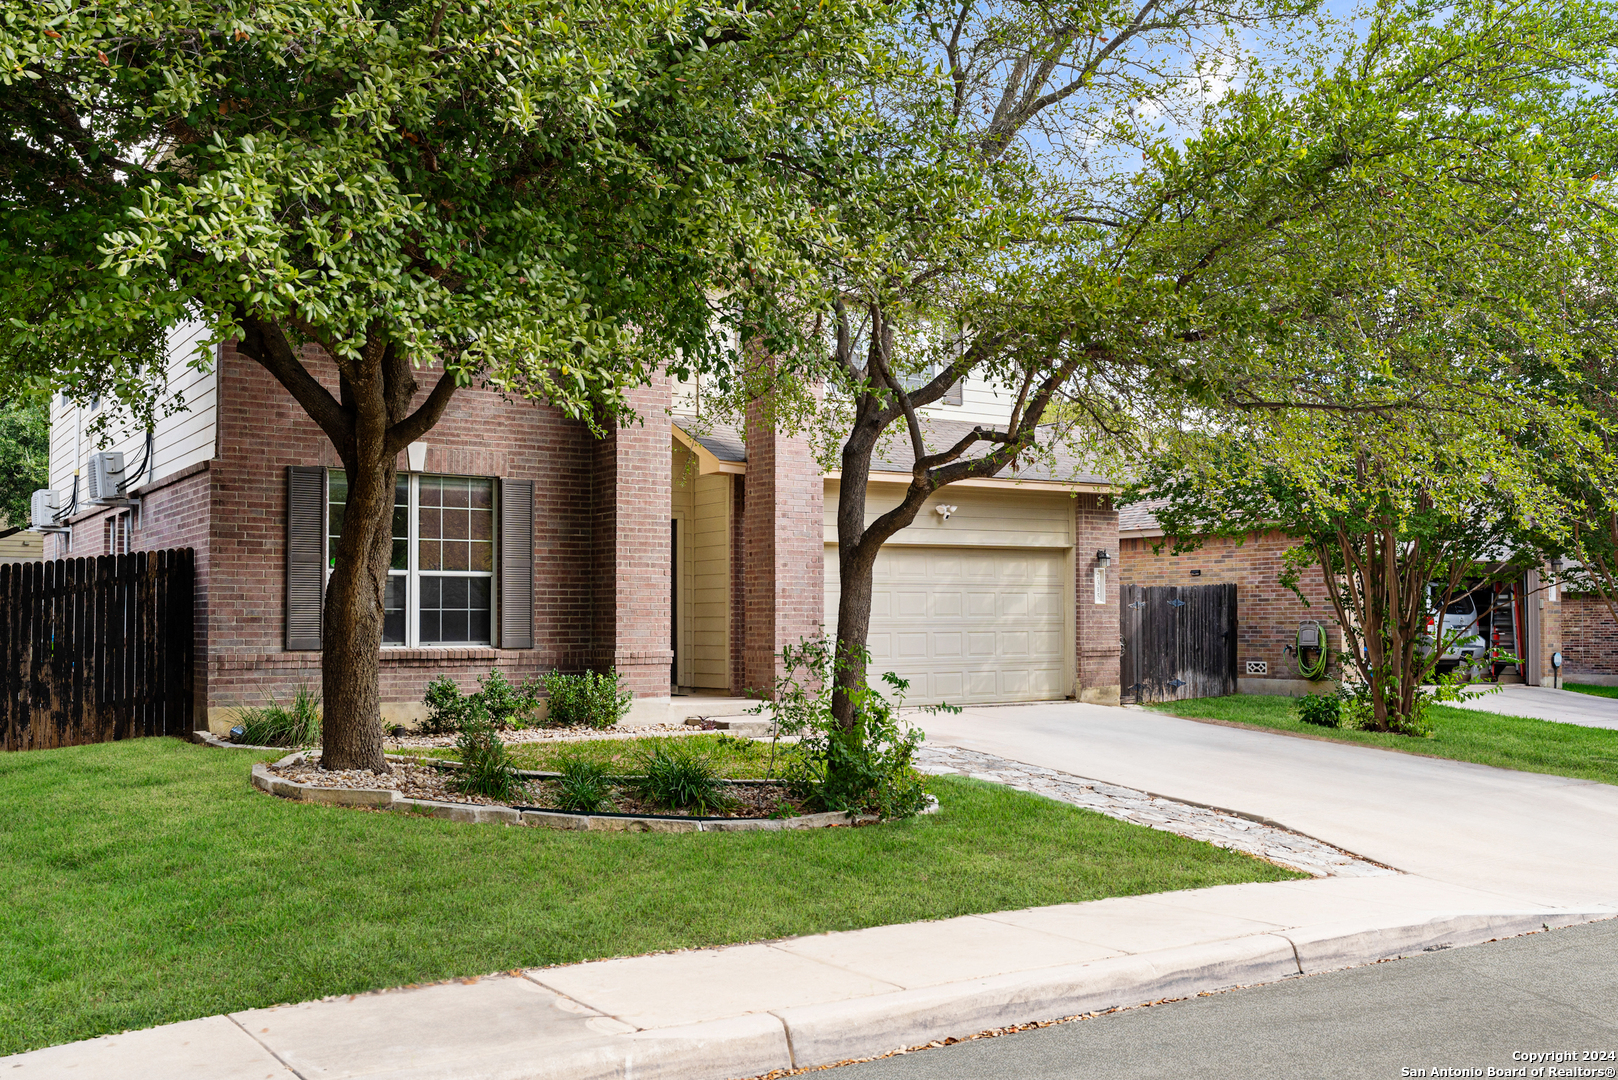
919;701;1618;905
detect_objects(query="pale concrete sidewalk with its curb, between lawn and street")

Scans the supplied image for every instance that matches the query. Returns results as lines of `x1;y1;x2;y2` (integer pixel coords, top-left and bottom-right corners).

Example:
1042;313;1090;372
9;874;1618;1080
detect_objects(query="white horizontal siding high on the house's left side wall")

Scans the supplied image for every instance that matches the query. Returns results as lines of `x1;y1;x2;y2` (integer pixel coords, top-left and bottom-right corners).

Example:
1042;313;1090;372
50;322;218;495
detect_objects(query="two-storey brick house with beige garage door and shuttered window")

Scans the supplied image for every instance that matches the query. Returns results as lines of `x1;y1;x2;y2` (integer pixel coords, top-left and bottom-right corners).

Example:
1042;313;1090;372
44;327;1118;730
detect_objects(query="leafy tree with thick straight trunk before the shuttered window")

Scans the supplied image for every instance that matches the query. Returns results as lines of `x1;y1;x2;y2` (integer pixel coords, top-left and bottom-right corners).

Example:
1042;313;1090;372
0;0;870;771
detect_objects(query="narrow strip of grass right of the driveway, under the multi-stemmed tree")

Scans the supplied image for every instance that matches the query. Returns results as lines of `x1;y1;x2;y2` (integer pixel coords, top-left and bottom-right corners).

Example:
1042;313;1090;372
1147;693;1618;784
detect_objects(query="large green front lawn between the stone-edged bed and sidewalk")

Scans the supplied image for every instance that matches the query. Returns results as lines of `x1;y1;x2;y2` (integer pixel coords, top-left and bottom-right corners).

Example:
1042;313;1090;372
0;738;1296;1054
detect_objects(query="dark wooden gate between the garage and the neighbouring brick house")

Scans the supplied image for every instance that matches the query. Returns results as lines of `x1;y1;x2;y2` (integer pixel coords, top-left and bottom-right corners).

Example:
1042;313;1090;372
1120;585;1236;703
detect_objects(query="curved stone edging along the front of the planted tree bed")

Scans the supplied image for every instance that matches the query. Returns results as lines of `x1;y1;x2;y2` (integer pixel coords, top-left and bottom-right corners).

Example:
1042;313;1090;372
252;746;938;832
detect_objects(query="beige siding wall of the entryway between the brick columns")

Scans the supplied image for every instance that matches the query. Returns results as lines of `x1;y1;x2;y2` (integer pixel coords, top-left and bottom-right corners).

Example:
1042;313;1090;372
670;445;731;690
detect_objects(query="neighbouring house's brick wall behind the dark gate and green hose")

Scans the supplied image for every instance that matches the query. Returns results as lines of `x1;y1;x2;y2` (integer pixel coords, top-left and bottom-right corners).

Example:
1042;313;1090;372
1120;531;1343;680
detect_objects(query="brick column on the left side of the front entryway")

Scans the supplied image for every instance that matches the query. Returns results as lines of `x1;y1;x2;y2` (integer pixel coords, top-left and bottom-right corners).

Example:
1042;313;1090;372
591;376;675;724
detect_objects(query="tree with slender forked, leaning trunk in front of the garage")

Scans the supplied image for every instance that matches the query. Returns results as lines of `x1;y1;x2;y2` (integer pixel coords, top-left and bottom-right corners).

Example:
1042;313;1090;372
715;0;1612;729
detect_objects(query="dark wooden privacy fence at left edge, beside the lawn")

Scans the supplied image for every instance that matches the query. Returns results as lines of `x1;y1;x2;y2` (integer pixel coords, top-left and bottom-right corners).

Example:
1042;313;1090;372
0;547;196;750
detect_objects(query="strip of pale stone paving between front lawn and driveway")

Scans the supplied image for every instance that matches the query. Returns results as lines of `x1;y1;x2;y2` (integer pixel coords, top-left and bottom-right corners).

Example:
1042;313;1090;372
916;745;1398;878
